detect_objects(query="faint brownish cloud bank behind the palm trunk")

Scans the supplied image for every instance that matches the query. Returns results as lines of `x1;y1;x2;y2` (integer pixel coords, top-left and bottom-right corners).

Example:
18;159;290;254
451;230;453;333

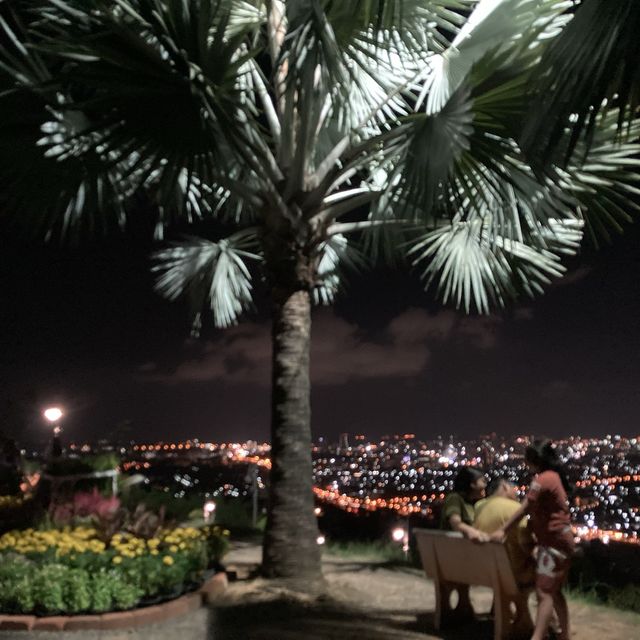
138;309;510;386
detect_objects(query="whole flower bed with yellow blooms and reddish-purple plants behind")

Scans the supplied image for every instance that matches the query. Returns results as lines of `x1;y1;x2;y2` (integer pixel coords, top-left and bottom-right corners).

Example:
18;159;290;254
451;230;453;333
0;450;229;616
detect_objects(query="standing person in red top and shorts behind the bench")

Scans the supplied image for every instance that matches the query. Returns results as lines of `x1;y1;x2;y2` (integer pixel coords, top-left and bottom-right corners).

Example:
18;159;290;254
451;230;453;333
491;440;574;640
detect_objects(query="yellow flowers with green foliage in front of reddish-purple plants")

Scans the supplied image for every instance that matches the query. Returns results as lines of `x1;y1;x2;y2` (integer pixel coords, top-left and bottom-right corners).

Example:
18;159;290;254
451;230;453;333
0;526;228;615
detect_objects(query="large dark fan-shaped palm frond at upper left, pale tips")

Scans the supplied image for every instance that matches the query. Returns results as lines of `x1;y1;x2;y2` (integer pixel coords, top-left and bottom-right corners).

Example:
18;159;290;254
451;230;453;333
0;0;278;238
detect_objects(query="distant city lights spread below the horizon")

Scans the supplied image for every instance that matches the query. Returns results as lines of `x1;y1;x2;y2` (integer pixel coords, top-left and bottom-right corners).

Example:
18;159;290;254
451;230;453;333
70;433;640;544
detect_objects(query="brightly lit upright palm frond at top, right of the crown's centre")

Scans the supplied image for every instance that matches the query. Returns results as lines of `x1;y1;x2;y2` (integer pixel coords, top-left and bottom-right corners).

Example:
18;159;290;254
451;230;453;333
280;0;472;193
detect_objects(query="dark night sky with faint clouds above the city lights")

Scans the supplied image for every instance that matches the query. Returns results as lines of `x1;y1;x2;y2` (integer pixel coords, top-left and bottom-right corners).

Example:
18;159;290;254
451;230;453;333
0;218;640;443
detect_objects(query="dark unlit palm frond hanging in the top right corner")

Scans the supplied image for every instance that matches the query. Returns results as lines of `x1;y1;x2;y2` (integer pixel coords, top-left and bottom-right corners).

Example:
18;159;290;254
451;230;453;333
523;0;640;165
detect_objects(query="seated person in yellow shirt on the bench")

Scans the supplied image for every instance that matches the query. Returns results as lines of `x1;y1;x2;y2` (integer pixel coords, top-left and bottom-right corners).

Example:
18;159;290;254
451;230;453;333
473;478;535;589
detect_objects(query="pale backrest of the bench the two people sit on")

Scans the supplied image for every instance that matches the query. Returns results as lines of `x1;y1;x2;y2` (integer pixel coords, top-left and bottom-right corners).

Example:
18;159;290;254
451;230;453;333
414;529;518;596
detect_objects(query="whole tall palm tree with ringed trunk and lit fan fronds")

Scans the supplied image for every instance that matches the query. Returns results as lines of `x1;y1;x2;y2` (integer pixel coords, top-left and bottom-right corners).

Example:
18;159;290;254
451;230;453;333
0;0;638;586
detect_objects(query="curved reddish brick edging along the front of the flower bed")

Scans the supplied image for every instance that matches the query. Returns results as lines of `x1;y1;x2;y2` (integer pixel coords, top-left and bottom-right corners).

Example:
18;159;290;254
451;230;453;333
0;571;228;631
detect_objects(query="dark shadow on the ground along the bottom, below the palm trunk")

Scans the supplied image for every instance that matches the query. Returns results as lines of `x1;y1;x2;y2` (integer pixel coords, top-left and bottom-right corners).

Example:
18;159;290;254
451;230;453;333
208;595;493;640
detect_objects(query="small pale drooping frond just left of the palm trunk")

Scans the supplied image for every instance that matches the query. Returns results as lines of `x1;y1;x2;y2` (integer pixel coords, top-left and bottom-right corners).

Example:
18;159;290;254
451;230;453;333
152;229;261;327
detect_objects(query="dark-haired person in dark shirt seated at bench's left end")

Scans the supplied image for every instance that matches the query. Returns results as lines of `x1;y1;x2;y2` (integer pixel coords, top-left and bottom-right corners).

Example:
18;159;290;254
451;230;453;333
440;467;489;542
